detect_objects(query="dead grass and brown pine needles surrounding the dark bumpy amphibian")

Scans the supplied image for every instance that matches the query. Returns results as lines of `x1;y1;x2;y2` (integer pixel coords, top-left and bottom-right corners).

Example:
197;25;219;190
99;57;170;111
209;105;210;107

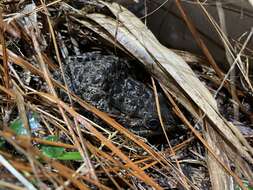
0;0;253;189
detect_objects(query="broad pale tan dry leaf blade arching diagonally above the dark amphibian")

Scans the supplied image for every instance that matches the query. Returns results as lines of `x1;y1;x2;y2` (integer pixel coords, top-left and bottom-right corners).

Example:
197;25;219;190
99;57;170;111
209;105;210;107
88;4;253;162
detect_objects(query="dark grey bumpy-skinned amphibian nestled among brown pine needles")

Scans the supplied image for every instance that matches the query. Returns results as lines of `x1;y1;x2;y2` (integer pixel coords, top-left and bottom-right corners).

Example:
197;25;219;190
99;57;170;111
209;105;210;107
56;52;174;136
